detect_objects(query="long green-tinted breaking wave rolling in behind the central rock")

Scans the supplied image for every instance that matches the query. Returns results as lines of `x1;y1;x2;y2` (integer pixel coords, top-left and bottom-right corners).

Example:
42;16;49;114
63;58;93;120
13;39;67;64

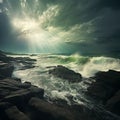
41;54;120;78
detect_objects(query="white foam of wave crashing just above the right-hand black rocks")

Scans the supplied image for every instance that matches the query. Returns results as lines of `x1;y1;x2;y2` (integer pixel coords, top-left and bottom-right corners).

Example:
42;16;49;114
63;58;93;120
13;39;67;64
80;57;120;77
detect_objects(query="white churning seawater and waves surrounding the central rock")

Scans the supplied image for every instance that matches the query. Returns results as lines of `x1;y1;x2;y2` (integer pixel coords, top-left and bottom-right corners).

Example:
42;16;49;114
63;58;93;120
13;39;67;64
13;54;120;104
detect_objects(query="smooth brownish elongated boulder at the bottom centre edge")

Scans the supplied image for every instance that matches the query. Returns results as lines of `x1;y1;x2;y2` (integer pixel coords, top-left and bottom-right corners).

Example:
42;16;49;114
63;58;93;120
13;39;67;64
29;98;75;120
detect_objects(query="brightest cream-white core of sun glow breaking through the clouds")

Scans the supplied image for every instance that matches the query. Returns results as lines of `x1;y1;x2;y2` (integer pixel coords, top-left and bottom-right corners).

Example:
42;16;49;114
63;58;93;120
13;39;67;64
12;13;60;52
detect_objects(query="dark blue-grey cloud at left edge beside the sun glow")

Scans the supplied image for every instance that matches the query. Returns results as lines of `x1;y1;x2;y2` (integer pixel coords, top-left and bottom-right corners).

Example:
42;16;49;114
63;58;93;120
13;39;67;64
0;12;26;52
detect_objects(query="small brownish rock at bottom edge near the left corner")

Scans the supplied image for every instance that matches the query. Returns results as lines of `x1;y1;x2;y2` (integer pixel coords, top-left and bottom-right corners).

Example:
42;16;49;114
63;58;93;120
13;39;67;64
5;106;30;120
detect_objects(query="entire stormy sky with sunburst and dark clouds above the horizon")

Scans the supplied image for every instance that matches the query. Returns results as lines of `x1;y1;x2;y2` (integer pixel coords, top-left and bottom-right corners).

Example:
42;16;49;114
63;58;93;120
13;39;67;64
0;0;120;57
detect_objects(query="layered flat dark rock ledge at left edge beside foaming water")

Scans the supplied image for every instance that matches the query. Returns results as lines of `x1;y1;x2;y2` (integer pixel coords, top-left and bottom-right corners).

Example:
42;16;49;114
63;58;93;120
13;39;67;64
0;79;44;103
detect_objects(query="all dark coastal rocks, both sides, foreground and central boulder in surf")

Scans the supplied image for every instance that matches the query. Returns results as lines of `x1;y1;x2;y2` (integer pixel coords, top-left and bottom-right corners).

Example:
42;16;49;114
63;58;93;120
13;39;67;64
0;51;120;120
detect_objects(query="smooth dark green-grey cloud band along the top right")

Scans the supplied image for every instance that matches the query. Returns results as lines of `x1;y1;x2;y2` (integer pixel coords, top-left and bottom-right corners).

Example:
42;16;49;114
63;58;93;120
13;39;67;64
45;0;120;29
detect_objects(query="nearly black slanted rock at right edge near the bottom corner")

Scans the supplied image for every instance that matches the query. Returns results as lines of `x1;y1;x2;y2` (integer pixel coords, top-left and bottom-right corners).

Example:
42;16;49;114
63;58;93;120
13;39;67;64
106;90;120;115
